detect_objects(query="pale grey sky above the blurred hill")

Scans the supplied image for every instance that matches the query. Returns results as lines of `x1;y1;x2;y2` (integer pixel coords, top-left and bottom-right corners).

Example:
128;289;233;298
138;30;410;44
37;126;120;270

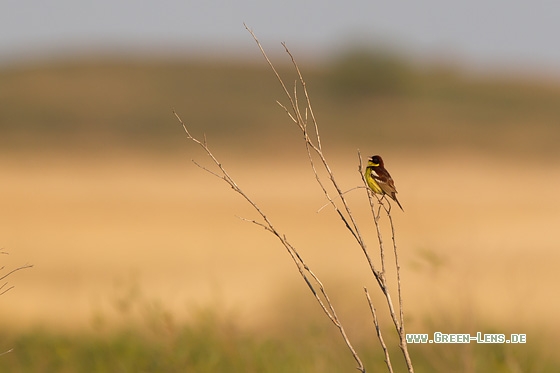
0;0;560;74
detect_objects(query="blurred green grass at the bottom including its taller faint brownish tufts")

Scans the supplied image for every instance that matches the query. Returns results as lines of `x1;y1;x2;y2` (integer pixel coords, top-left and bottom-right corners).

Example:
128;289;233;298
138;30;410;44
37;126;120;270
0;278;560;373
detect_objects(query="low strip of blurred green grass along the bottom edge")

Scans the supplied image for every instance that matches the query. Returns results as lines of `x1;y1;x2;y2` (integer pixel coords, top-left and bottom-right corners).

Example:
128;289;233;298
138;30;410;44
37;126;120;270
0;311;560;373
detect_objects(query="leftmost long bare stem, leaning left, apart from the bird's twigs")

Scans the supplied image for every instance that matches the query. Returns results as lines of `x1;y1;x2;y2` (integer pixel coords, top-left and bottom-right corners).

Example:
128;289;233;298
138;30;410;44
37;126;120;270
173;111;365;373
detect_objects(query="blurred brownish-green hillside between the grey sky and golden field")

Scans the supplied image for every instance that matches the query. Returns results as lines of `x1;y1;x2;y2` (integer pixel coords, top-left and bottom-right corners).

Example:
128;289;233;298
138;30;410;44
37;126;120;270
0;49;560;156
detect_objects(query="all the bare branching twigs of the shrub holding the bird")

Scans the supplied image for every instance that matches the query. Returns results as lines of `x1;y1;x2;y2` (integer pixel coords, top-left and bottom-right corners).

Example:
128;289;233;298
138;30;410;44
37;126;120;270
174;25;414;373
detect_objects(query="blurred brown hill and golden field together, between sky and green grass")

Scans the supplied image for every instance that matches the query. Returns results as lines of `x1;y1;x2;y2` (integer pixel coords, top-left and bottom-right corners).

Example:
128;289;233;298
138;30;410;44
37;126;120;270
0;53;560;371
